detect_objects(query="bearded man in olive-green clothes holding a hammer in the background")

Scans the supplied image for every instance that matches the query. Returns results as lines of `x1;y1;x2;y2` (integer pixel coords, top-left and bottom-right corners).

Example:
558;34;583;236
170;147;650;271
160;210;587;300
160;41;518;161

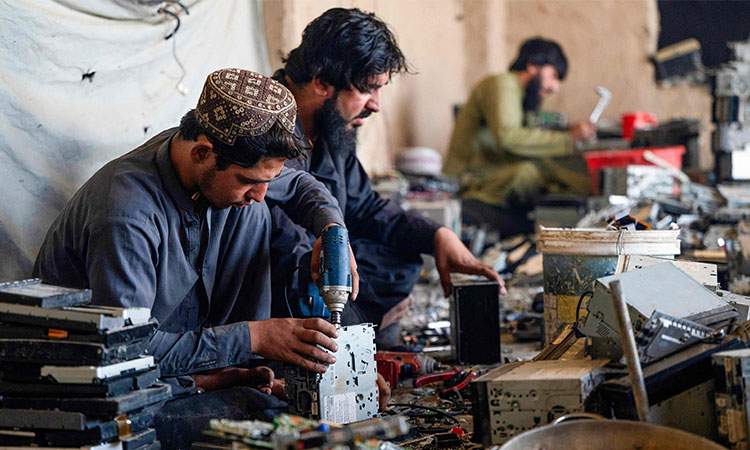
443;38;594;236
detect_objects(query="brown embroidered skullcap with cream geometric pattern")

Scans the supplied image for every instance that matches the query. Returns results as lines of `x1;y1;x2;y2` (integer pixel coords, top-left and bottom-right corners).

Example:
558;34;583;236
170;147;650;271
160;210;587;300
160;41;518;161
195;69;297;145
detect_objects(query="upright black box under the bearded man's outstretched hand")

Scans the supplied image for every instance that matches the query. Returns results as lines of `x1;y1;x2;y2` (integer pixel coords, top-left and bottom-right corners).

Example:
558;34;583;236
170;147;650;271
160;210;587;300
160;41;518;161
450;280;502;364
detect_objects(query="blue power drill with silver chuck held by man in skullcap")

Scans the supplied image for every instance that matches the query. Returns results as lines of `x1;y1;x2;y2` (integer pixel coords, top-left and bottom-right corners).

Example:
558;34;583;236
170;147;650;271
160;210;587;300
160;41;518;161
320;225;352;328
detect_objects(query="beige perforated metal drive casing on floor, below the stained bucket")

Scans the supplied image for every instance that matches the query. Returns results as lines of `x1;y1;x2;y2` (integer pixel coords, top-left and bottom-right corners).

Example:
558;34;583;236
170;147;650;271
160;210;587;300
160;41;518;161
471;359;609;447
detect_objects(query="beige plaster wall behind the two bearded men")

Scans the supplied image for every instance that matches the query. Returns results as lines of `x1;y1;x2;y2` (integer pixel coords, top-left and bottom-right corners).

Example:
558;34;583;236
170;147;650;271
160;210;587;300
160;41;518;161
263;0;711;173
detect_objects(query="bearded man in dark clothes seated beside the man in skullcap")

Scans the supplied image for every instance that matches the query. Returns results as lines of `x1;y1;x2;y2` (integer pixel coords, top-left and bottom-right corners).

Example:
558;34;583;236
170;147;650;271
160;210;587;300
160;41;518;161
272;8;505;348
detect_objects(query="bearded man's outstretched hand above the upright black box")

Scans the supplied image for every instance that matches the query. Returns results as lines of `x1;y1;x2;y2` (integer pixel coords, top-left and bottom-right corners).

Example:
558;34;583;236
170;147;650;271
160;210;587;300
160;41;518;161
433;227;506;297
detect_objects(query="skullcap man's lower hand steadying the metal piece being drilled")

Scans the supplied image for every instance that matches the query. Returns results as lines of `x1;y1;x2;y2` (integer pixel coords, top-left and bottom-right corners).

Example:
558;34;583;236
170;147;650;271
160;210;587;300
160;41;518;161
248;319;338;373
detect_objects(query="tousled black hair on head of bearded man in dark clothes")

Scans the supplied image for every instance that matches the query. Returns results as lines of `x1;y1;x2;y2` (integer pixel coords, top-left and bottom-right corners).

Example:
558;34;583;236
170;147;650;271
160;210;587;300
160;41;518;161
282;8;410;92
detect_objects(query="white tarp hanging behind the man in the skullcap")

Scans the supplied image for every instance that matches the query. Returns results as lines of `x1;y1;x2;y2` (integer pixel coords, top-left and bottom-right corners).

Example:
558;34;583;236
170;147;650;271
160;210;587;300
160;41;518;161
0;0;270;281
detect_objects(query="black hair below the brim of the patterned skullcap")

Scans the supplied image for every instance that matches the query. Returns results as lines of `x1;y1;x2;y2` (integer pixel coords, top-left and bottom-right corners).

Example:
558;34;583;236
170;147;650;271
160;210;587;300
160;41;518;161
180;109;309;171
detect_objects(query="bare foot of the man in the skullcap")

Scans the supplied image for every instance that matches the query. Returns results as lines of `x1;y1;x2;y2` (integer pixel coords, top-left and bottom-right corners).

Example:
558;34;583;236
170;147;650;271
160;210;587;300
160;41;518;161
191;366;286;399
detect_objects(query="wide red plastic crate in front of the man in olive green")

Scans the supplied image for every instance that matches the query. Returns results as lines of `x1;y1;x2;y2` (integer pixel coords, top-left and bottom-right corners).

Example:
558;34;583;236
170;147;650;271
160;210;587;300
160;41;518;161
583;145;685;195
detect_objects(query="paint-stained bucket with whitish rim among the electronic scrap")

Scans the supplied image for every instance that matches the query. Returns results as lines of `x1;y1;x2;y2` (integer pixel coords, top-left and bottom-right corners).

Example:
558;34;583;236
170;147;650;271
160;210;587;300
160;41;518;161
537;227;680;343
